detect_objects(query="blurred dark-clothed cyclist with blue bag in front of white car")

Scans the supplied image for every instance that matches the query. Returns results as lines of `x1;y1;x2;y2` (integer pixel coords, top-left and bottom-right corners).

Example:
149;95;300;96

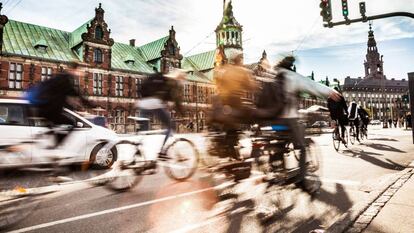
26;63;93;149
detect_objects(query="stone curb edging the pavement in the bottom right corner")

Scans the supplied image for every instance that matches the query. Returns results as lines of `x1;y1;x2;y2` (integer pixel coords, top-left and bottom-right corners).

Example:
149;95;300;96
326;161;414;233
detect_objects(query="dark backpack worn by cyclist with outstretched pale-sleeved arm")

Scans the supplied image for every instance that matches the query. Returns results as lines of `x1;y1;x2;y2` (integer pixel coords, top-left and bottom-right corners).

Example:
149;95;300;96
255;72;286;120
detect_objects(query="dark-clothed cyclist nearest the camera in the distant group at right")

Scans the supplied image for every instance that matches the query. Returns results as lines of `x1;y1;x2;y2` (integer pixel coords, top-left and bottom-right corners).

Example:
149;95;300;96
328;87;348;144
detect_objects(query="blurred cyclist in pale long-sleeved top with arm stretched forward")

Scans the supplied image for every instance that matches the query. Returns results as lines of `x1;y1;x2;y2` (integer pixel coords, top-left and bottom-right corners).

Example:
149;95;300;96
266;56;341;193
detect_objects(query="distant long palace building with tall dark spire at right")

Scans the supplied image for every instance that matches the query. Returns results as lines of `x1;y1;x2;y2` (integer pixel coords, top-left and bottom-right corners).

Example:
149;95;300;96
343;25;409;120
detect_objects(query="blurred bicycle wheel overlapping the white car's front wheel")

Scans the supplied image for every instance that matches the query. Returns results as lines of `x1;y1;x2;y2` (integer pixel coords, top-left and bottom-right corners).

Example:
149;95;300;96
98;141;146;192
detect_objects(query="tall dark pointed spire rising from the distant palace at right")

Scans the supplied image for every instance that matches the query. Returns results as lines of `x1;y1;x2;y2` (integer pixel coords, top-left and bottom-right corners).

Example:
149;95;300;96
364;23;385;79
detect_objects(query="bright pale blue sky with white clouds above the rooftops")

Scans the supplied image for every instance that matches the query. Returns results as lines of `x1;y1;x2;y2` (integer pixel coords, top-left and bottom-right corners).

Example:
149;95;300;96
2;0;414;83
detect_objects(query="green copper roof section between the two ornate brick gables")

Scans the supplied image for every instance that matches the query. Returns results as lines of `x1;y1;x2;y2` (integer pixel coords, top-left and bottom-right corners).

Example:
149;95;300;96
112;42;153;73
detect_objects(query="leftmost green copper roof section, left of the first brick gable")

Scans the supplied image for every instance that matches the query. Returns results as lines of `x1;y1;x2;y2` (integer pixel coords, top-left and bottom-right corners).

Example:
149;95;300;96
3;20;77;62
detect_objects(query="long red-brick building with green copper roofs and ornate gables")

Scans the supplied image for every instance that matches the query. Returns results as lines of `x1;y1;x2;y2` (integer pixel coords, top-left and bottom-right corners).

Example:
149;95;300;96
0;0;323;133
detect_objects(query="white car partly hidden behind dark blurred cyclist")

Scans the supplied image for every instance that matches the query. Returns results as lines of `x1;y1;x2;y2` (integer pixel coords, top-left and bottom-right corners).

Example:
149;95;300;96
0;99;118;168
